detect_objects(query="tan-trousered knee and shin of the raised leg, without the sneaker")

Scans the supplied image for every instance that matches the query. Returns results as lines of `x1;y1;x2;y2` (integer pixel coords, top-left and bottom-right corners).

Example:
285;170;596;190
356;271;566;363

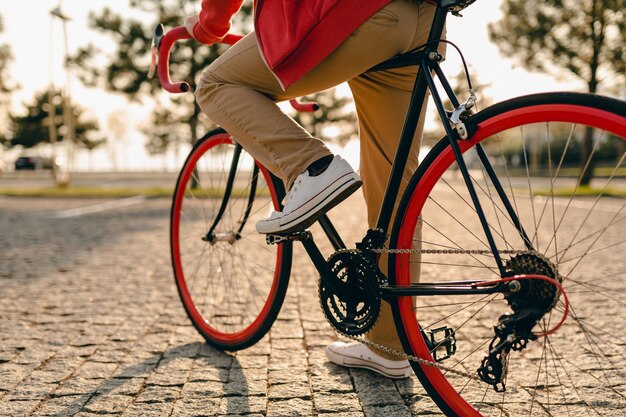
196;33;331;189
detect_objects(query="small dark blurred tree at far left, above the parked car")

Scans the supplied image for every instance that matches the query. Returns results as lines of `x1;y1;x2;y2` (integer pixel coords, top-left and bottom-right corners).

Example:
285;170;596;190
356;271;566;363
7;90;105;150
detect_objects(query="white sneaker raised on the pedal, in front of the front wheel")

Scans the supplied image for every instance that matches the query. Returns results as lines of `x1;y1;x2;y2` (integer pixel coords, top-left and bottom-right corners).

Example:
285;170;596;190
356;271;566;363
256;155;361;234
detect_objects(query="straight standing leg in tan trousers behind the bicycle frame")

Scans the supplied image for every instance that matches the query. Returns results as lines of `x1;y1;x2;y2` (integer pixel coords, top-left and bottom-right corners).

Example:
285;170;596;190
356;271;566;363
349;3;435;359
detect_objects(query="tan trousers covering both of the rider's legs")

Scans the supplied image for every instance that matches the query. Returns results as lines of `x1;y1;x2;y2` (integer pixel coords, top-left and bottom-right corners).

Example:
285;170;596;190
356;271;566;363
197;0;432;372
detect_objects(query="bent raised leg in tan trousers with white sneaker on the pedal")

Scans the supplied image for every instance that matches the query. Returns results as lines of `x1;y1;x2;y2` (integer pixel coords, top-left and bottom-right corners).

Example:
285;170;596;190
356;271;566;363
197;34;361;234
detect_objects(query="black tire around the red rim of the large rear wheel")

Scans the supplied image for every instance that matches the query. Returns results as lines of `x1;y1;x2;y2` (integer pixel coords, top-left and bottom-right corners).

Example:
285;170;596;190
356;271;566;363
388;92;626;417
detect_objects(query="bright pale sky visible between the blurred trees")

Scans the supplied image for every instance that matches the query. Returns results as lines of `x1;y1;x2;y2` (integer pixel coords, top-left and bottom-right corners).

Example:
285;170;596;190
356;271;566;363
0;0;582;169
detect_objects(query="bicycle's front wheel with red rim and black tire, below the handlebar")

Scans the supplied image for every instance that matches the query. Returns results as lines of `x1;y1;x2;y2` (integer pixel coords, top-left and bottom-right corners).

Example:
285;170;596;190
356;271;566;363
170;130;292;350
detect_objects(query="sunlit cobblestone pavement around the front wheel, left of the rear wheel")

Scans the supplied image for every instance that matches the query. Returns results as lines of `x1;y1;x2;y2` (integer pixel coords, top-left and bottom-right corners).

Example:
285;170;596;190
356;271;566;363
0;193;623;417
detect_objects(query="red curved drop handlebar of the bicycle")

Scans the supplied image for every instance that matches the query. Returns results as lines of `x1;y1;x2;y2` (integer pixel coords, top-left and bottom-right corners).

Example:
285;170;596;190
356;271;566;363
148;24;319;112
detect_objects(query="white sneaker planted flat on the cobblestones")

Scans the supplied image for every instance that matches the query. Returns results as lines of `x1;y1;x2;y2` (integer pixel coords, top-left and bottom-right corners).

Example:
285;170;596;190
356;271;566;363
326;342;413;379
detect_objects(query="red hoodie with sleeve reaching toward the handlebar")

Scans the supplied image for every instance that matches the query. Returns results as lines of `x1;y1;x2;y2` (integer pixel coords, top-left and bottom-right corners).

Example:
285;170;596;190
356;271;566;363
193;0;391;89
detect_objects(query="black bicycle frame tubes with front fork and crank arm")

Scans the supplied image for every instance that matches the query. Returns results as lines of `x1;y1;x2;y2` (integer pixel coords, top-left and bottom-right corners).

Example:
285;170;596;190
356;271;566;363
210;3;532;299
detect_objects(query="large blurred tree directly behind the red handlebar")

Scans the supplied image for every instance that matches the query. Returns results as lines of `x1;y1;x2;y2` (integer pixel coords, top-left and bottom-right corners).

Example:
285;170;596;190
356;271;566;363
72;0;252;153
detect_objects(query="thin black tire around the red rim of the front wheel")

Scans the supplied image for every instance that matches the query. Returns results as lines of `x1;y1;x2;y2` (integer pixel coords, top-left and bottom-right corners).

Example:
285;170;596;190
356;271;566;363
169;128;293;351
